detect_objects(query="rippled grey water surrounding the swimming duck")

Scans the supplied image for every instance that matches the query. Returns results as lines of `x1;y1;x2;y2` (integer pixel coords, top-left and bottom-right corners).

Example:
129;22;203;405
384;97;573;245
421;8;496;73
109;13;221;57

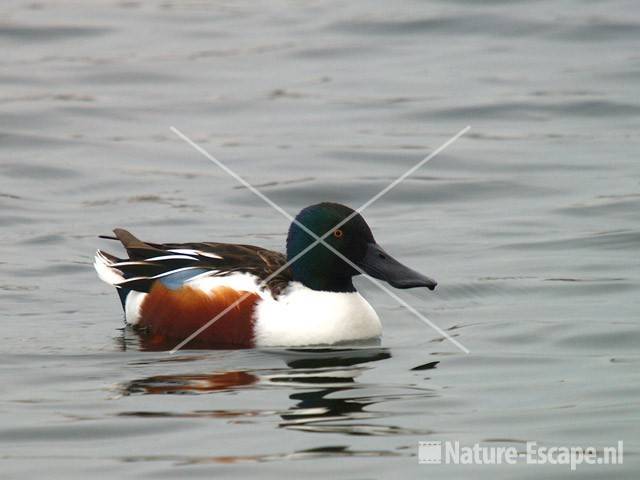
0;0;640;479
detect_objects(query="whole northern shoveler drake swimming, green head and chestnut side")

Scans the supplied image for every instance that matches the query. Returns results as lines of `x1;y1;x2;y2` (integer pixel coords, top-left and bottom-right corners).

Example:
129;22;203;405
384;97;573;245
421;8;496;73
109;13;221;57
94;203;436;348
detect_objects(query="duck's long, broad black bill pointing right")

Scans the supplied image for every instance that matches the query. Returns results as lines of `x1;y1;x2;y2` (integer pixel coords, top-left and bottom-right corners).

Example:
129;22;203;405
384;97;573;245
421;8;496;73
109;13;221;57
358;243;437;290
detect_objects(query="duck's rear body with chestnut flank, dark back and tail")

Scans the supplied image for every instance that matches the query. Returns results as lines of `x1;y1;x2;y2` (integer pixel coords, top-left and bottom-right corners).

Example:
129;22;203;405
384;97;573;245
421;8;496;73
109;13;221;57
94;229;291;348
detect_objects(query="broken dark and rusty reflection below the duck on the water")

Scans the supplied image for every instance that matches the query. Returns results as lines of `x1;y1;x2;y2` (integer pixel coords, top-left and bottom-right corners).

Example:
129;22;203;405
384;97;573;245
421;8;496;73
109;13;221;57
123;348;437;435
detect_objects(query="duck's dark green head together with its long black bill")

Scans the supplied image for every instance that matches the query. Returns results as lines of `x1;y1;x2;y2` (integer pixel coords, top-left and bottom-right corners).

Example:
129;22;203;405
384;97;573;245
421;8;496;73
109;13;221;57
287;202;437;292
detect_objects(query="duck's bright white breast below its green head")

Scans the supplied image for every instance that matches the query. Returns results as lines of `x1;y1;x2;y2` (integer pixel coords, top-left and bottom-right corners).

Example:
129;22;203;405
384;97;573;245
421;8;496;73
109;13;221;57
255;282;382;347
